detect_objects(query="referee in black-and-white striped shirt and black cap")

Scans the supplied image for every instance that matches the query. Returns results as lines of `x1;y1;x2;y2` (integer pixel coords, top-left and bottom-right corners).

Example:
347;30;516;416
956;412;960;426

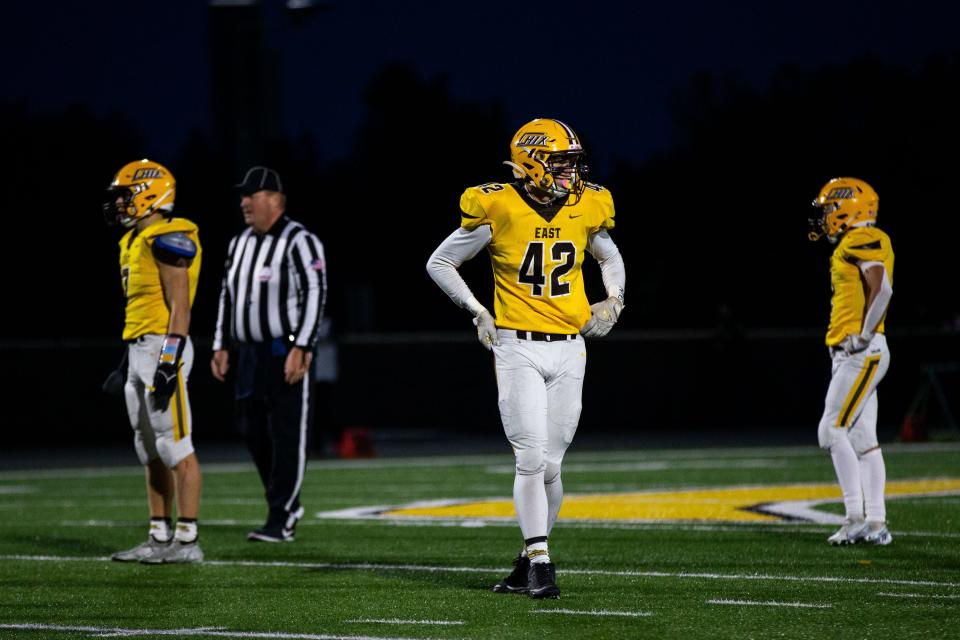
210;167;326;542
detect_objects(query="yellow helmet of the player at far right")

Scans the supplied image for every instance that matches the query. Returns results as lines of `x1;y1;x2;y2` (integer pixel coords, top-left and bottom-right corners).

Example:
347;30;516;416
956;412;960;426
807;178;880;242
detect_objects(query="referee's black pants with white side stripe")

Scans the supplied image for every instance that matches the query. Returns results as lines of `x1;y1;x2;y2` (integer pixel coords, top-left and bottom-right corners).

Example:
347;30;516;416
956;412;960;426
236;340;313;529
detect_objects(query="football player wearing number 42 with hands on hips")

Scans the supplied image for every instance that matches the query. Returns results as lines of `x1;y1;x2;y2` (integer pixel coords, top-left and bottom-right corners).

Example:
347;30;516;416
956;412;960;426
427;118;626;598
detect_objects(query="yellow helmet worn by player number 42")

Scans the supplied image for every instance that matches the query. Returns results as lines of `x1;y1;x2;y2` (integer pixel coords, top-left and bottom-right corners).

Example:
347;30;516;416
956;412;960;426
504;118;588;204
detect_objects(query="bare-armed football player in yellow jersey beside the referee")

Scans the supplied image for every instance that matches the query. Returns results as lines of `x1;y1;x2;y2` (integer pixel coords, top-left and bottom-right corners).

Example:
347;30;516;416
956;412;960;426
103;160;203;564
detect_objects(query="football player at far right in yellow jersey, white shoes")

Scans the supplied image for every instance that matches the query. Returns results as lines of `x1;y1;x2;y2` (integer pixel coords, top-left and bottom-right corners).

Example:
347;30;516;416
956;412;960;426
810;178;893;545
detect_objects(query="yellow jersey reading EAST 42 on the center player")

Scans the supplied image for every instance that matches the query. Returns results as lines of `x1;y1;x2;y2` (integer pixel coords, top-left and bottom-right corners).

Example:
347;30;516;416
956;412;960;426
460;182;614;334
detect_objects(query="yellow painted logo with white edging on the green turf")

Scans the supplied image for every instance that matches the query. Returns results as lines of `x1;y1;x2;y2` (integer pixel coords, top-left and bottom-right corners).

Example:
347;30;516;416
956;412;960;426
317;478;960;524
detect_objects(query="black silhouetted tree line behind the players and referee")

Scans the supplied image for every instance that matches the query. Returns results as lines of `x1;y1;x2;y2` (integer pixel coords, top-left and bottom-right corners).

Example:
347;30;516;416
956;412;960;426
0;56;960;337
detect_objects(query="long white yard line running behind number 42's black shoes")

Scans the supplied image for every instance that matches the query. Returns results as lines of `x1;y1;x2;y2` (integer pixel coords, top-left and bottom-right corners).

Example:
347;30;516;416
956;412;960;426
0;555;960;588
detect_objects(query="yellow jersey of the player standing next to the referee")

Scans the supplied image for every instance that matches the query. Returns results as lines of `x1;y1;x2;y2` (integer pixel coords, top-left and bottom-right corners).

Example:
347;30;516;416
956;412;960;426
120;218;201;340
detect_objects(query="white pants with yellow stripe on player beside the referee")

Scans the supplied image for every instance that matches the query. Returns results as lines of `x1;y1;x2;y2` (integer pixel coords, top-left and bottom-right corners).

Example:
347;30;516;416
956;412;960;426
123;334;193;469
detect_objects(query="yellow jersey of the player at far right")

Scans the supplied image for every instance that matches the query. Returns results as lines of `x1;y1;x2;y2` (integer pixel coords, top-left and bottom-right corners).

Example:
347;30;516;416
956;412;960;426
826;227;893;346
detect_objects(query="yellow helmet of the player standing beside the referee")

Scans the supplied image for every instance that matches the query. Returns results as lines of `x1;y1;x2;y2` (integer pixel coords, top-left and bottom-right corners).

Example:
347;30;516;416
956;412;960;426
103;158;177;228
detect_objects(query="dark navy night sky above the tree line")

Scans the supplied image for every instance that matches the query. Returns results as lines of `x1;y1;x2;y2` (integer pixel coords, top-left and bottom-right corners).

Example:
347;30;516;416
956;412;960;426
7;0;960;169
